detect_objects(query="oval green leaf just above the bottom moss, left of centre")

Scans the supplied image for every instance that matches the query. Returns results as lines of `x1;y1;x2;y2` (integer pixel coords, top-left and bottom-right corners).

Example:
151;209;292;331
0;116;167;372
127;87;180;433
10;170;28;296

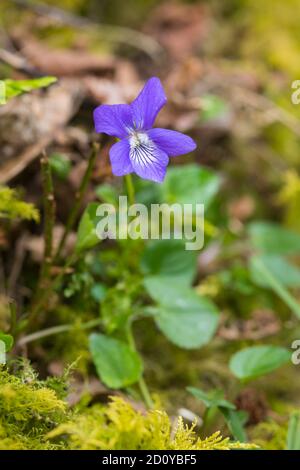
89;333;143;389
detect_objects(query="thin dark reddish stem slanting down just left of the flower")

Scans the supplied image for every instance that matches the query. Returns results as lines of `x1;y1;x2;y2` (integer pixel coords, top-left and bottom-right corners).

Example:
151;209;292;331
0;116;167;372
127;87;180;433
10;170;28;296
55;143;99;259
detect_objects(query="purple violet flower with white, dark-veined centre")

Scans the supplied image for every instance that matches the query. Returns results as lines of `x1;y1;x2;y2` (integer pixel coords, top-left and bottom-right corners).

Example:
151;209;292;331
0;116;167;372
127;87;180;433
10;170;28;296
94;77;196;183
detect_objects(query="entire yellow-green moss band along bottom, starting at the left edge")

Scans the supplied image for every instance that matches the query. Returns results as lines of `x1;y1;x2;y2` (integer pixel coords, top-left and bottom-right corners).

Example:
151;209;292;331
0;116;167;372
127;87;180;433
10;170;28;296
0;365;255;450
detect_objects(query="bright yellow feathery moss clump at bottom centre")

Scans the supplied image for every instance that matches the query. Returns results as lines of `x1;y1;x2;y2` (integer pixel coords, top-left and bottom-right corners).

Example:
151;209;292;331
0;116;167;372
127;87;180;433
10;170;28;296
48;397;255;450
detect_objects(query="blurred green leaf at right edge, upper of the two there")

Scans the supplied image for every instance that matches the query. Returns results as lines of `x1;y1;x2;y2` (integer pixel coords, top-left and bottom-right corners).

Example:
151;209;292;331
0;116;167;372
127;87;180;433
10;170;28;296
248;222;300;255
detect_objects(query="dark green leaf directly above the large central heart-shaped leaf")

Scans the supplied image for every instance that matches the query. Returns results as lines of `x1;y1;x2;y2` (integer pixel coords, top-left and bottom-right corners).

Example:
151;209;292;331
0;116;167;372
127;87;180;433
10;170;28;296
141;240;197;285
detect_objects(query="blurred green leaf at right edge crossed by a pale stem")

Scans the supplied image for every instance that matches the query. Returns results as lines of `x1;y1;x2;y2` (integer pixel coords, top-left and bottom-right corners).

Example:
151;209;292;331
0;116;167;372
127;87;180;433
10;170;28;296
250;255;300;288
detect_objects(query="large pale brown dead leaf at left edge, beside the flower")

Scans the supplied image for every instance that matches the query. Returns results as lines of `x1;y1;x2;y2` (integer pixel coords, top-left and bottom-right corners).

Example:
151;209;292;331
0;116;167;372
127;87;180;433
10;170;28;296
0;79;83;184
